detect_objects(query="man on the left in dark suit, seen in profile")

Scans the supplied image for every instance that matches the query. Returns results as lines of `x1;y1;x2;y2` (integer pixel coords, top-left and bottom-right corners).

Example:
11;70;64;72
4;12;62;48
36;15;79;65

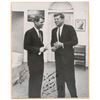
24;16;46;98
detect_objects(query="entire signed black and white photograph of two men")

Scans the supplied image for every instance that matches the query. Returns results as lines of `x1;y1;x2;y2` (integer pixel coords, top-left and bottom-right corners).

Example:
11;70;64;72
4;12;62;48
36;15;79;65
11;1;89;99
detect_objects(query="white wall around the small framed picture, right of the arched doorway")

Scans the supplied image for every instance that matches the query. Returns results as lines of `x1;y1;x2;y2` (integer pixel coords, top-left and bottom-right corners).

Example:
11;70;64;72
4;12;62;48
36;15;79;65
71;2;89;66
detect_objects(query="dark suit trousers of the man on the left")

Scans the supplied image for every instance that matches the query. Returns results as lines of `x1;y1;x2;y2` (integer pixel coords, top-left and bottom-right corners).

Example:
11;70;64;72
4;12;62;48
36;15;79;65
29;69;43;98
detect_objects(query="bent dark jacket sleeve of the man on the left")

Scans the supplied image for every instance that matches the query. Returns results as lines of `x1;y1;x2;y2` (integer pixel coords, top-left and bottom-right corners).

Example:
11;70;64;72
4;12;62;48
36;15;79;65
24;32;40;53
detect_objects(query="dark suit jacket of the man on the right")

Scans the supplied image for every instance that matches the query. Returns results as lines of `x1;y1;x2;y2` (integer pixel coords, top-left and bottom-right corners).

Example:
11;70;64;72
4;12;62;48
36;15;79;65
51;24;78;67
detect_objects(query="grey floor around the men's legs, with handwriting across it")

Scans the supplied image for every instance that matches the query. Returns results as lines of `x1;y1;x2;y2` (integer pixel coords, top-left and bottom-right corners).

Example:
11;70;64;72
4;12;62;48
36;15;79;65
12;62;89;98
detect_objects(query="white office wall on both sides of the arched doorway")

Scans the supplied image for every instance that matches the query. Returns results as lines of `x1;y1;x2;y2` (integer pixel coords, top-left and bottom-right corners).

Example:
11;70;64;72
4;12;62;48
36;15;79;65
12;2;89;66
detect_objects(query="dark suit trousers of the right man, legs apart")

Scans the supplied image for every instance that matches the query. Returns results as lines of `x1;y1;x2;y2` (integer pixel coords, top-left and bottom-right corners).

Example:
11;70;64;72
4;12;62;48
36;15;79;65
56;55;77;97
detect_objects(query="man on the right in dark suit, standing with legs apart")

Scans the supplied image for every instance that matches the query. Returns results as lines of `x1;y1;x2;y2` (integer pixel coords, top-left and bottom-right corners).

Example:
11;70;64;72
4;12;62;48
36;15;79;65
51;13;78;97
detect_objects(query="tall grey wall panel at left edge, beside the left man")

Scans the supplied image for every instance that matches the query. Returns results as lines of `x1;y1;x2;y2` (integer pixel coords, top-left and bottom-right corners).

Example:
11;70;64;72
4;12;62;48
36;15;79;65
11;11;24;53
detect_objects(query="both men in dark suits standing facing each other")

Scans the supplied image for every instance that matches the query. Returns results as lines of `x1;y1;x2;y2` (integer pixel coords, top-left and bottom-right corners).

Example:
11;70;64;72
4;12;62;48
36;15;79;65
24;13;78;98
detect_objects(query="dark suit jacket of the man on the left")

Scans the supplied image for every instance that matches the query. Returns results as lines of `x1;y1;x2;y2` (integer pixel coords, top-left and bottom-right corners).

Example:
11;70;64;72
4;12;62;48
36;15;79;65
24;27;43;71
